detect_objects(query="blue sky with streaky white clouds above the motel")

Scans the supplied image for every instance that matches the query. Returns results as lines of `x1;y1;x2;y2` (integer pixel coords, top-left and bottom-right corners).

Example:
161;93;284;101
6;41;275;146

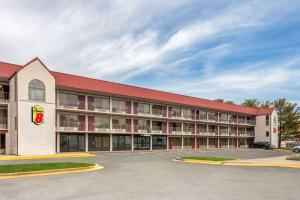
0;0;300;104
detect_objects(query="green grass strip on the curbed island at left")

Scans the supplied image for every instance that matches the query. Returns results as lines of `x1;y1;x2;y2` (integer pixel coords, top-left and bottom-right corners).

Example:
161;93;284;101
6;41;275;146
0;162;94;174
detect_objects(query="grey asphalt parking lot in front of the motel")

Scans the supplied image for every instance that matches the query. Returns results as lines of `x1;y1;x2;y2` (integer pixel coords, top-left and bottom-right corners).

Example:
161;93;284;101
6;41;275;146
0;150;300;200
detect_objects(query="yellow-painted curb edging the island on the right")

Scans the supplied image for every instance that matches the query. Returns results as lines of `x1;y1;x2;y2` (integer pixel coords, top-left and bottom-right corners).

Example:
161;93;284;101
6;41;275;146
177;159;300;169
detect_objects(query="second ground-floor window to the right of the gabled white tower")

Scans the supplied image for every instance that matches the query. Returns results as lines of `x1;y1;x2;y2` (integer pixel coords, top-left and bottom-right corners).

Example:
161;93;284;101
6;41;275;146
89;134;110;151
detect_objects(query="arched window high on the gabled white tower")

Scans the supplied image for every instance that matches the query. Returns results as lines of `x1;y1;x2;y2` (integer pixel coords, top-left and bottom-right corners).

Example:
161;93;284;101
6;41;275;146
28;79;46;101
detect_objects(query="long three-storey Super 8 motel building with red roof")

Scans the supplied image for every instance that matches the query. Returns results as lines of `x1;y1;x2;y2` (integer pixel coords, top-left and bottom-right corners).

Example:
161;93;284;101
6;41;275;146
0;58;278;155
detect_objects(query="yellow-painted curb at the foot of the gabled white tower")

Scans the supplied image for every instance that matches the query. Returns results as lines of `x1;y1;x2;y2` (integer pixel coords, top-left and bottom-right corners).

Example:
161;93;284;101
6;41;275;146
0;153;96;160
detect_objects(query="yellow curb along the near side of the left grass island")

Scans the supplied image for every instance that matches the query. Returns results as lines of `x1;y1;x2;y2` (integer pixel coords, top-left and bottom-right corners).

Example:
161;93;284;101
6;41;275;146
0;164;104;180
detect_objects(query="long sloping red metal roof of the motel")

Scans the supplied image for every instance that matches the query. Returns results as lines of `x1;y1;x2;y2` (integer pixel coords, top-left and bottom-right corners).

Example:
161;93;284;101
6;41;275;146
0;59;274;115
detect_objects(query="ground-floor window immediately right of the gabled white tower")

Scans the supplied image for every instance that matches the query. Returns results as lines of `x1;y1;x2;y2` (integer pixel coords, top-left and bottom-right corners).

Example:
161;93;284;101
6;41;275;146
60;133;85;152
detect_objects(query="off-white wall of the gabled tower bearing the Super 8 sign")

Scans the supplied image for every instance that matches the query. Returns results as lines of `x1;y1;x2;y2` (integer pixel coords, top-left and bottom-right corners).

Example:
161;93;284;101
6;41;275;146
17;60;55;155
